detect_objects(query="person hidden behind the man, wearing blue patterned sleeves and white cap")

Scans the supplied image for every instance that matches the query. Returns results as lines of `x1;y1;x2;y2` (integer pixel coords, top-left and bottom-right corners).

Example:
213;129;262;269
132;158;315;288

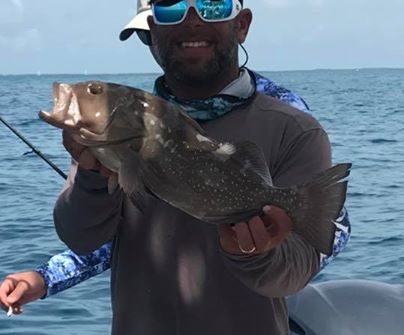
0;1;349;330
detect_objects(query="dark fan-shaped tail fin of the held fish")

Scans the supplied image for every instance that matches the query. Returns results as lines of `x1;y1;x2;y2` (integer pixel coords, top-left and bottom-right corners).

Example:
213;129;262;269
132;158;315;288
278;163;352;255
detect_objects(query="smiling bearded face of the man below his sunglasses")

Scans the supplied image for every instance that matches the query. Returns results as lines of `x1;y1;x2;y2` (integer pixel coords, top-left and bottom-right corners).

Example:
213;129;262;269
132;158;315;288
149;8;249;85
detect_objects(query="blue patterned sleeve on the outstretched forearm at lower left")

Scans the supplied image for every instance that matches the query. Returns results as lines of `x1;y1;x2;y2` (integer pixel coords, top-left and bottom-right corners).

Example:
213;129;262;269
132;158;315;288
35;242;112;298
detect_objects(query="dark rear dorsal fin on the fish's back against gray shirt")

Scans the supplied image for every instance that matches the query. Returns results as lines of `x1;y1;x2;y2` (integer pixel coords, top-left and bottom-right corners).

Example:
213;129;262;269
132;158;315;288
231;142;272;186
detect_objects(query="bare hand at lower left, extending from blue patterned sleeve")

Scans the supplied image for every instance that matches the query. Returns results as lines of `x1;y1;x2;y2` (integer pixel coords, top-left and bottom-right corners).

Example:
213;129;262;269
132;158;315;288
0;271;47;314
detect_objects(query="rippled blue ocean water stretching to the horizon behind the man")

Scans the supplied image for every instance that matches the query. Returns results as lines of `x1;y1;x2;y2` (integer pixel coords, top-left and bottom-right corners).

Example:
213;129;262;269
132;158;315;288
0;69;404;335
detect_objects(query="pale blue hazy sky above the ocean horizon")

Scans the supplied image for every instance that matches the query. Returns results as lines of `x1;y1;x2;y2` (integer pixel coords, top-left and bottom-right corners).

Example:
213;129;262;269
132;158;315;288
0;0;404;74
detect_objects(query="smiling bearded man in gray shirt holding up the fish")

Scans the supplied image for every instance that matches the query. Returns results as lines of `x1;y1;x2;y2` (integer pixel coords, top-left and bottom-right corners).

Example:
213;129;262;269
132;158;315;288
49;0;348;335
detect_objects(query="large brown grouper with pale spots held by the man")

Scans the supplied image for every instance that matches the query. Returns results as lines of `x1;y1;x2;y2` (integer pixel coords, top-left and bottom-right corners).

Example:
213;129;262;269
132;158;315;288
39;81;351;255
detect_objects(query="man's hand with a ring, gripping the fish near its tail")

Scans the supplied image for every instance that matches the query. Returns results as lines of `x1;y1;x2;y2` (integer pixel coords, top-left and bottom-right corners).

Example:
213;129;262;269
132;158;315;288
218;206;292;255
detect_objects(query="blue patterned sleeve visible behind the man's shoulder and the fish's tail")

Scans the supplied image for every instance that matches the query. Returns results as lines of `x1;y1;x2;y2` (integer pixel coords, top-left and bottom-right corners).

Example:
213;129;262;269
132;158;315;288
253;72;351;270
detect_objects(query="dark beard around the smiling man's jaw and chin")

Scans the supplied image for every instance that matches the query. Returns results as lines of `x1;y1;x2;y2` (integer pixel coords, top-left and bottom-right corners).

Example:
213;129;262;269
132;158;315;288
152;29;238;87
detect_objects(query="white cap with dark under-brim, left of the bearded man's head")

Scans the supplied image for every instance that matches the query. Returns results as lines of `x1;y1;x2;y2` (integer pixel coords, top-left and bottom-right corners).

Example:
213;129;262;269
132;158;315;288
119;0;152;45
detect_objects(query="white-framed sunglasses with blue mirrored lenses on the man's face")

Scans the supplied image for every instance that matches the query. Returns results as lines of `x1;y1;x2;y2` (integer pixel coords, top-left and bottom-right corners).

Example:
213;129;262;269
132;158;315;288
152;0;242;25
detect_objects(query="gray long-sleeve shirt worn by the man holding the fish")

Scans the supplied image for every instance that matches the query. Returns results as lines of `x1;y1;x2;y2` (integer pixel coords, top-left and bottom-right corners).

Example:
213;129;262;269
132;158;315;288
55;94;331;335
